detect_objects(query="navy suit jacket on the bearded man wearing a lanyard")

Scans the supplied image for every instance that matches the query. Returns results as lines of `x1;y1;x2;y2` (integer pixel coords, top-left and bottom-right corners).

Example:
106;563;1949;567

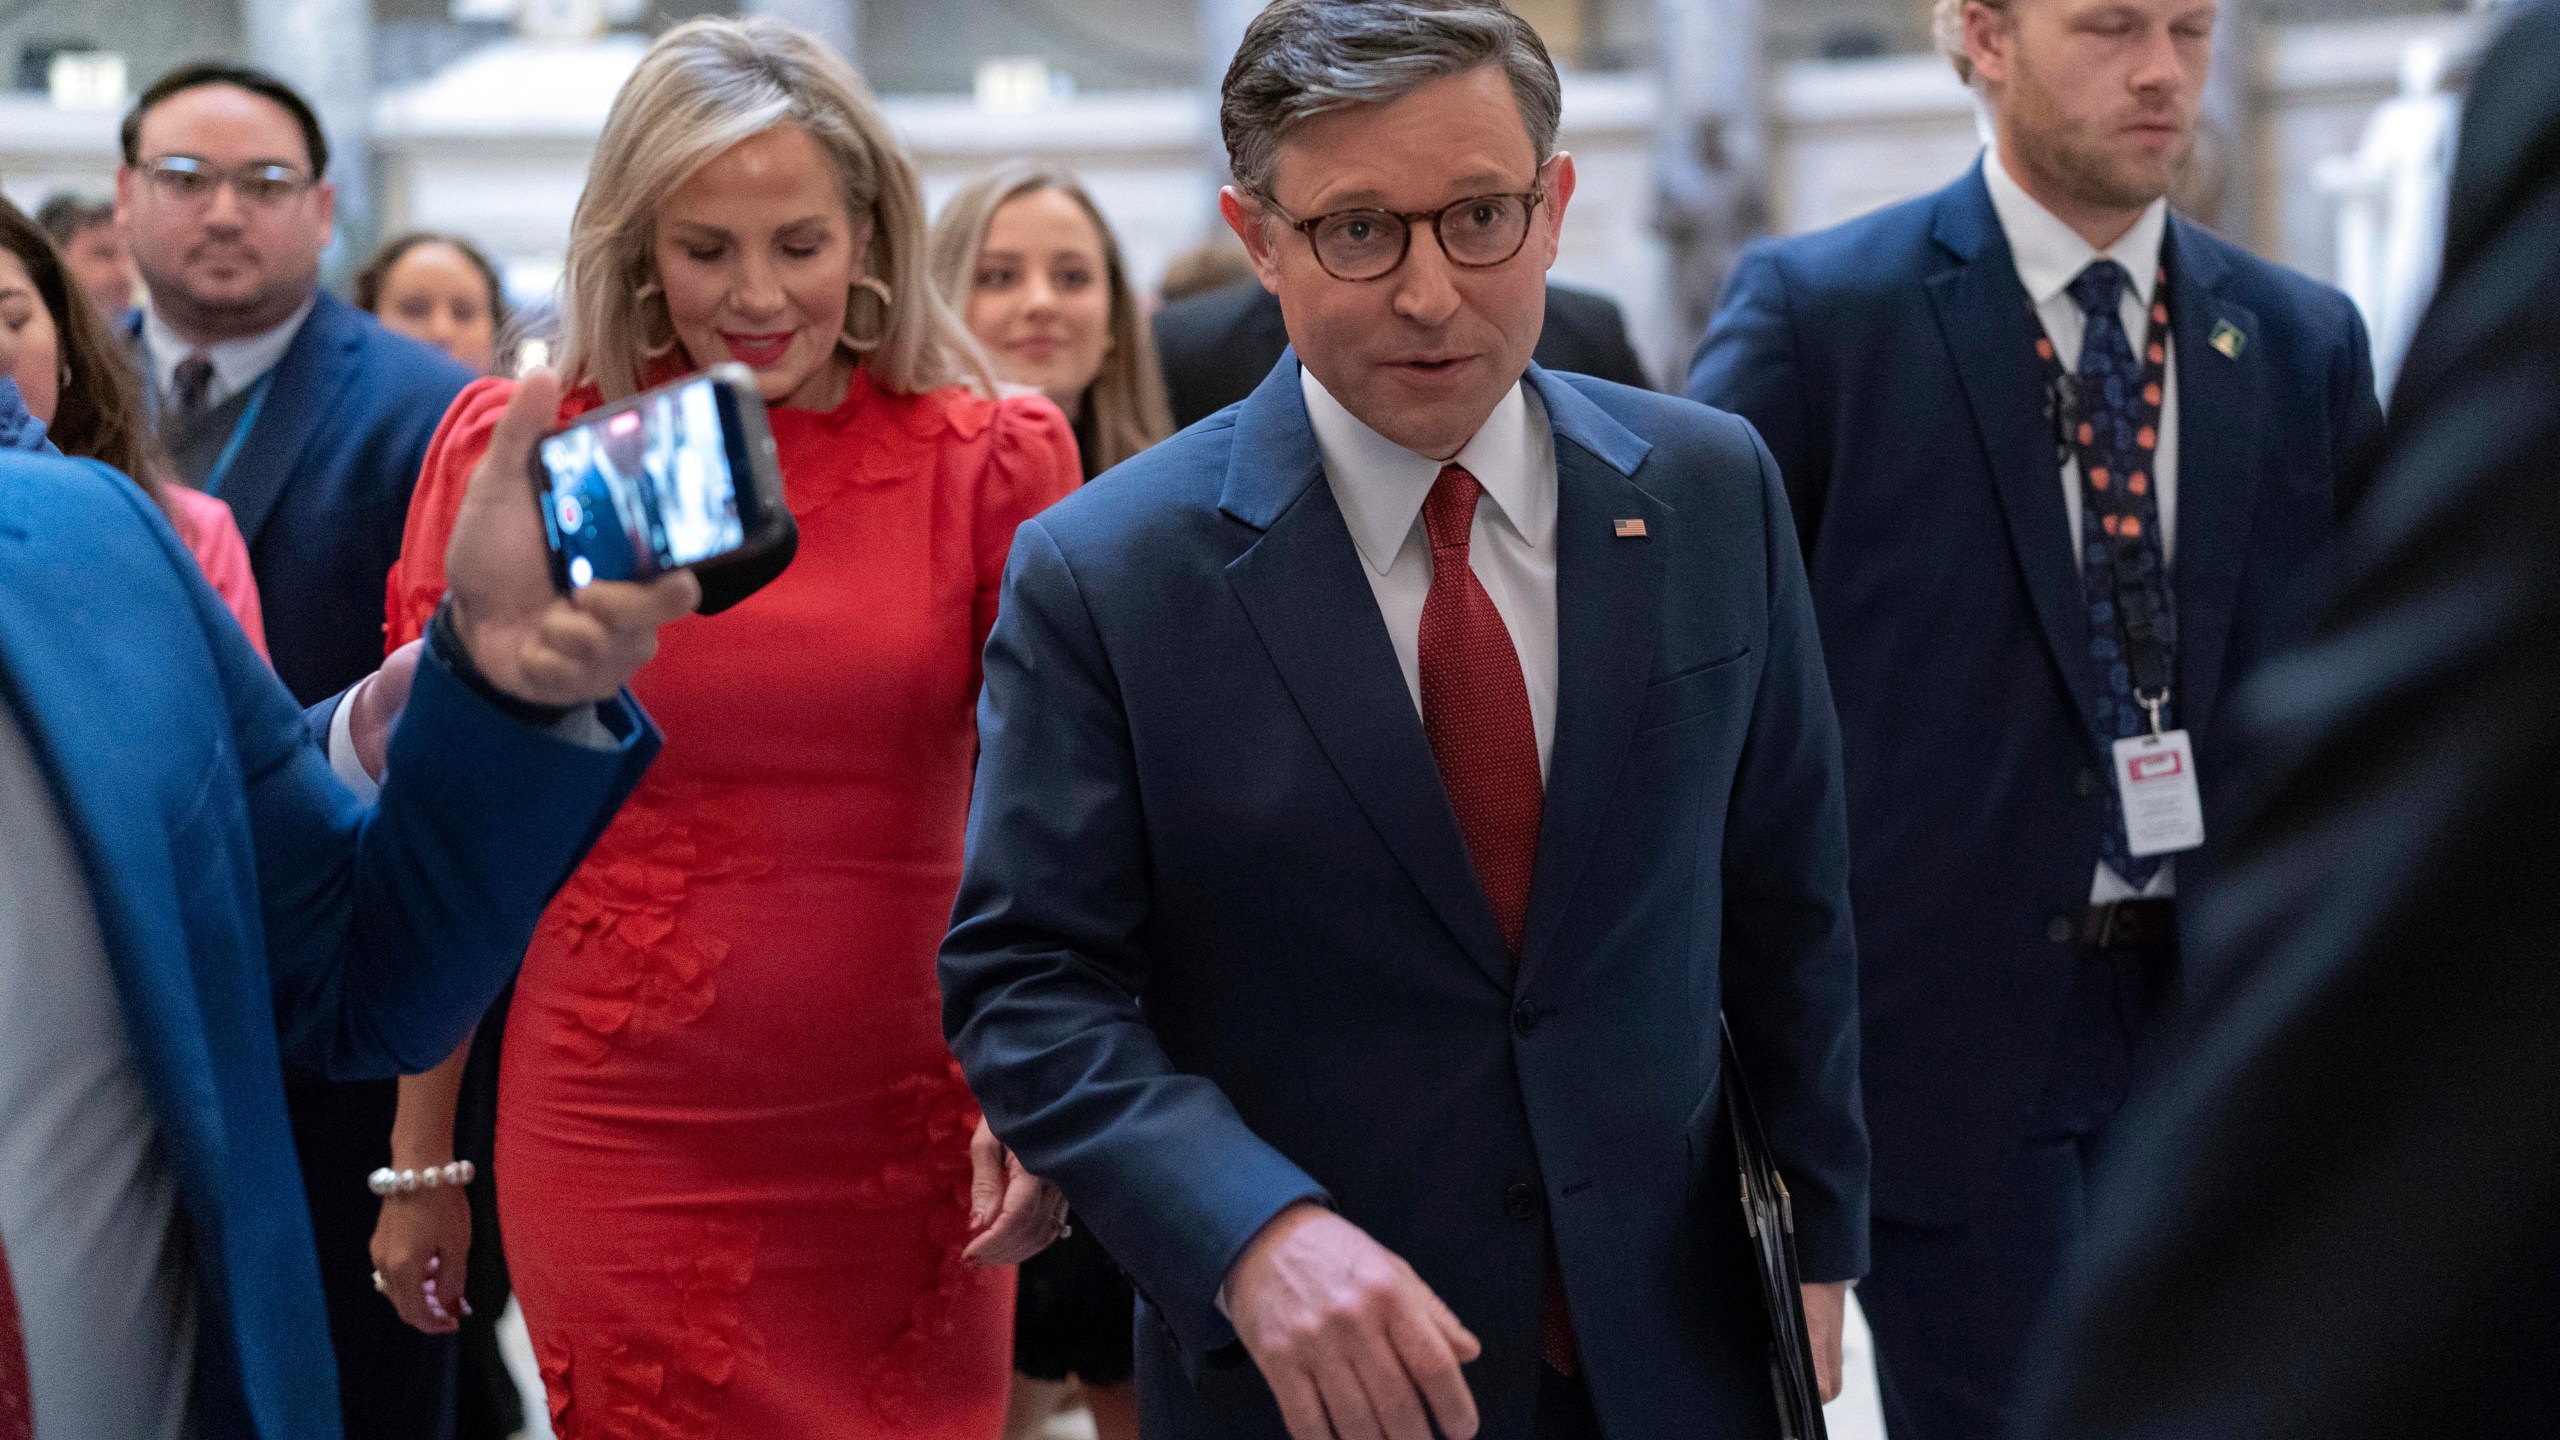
1690;167;2381;1225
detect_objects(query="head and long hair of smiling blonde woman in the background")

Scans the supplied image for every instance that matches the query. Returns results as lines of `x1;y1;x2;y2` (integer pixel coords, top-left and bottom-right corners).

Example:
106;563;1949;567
932;161;1172;479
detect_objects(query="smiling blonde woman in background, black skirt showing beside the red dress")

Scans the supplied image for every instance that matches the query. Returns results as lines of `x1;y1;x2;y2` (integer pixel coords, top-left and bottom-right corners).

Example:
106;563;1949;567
932;161;1172;1440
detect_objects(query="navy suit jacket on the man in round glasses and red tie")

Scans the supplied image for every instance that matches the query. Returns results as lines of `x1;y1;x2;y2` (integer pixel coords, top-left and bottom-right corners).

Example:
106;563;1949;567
942;356;1866;1440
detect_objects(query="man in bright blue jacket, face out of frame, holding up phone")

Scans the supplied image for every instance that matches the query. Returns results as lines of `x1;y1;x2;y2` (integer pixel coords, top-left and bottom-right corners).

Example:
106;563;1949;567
0;379;699;1440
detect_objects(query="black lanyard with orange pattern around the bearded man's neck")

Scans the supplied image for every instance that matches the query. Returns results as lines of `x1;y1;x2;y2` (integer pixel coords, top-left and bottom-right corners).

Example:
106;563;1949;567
2035;264;2179;728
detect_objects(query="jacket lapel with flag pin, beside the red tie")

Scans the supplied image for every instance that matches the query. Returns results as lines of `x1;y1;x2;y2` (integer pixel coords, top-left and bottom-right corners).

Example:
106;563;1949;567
1521;369;1672;979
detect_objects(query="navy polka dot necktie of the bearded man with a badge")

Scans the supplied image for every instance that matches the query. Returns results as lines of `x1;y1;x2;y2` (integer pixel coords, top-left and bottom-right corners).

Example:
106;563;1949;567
2071;259;2176;889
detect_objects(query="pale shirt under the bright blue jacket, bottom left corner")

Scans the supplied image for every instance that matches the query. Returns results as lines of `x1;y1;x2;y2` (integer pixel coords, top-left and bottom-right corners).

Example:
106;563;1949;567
0;702;197;1440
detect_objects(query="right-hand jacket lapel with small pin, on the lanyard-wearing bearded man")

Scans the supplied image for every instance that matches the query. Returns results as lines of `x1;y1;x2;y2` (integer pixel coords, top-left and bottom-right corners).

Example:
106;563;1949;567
2168;218;2268;728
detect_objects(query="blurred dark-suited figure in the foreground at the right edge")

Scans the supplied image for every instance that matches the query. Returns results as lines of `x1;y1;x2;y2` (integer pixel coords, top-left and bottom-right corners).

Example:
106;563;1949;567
2030;0;2560;1440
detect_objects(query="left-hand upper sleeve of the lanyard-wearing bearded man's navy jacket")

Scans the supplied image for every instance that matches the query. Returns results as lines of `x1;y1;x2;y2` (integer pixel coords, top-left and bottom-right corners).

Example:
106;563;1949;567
1690;241;1830;553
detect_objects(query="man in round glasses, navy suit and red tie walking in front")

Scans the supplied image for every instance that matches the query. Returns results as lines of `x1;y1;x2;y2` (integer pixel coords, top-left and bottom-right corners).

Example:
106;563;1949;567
942;0;1866;1440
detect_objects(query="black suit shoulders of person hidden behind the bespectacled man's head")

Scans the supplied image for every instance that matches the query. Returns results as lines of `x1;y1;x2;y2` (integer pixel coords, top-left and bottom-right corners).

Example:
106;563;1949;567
1155;279;1651;425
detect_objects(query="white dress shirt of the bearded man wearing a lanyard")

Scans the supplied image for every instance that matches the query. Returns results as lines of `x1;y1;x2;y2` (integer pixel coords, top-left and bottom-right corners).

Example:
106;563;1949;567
1981;146;2179;904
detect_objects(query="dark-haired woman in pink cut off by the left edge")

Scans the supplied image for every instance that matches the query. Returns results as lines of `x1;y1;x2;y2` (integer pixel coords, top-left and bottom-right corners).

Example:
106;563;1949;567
0;200;266;656
